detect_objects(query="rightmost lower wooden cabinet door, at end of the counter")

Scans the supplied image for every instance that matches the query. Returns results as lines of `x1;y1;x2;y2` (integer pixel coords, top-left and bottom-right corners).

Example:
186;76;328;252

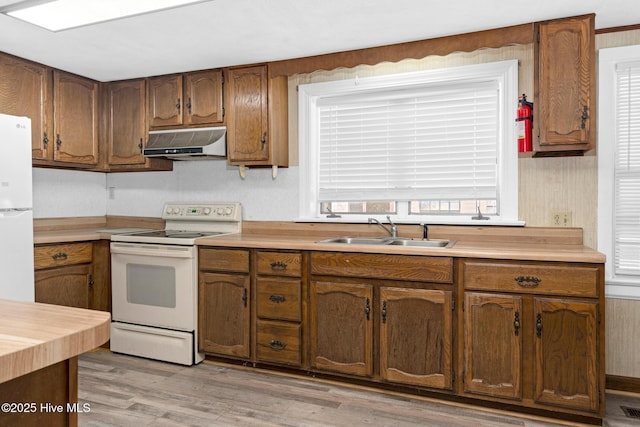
533;298;599;411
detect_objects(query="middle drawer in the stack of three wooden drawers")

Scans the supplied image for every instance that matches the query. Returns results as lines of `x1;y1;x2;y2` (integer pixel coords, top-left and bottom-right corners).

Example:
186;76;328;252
257;277;301;322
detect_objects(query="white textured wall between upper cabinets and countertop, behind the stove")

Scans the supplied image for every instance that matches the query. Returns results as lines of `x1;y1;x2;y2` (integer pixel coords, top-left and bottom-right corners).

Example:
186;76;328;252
33;160;298;221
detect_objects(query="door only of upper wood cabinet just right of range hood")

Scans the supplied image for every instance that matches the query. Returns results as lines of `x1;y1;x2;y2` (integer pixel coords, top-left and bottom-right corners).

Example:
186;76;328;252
225;66;269;164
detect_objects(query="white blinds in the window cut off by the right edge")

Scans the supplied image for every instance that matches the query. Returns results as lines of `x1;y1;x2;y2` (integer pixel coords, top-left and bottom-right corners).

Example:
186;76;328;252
613;62;640;276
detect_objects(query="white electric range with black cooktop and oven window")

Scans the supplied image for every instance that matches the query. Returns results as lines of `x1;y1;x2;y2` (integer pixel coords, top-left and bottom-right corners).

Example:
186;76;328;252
111;202;242;365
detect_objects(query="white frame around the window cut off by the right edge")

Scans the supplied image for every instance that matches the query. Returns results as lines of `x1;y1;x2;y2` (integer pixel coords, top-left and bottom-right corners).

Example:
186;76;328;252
597;45;640;299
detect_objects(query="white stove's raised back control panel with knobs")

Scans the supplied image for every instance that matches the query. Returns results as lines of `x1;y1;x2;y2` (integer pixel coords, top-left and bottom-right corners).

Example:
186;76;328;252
162;202;242;222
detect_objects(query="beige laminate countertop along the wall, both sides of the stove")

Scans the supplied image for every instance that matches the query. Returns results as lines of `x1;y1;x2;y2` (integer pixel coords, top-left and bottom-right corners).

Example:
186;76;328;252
34;229;605;263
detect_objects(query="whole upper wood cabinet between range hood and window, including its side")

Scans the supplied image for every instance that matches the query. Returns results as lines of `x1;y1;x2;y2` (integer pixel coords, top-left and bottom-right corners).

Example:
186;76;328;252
225;65;289;166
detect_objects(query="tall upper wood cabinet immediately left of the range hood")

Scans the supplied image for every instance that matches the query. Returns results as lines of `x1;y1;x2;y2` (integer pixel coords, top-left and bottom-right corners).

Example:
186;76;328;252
101;79;173;171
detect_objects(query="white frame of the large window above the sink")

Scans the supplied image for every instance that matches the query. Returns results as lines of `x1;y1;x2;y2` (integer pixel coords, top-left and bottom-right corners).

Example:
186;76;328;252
297;60;524;225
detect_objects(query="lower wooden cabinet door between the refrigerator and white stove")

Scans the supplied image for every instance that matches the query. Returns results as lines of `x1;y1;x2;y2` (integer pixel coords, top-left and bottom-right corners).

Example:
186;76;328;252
35;264;91;308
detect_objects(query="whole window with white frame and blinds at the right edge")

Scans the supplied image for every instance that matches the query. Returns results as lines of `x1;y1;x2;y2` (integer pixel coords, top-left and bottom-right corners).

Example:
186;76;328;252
598;42;640;299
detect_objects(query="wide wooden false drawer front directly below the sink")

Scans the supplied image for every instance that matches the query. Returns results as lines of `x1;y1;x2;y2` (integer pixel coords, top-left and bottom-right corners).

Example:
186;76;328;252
311;252;453;283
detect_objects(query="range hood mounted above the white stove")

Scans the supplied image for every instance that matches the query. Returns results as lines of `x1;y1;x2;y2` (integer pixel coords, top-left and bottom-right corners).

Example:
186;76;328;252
142;127;227;160
